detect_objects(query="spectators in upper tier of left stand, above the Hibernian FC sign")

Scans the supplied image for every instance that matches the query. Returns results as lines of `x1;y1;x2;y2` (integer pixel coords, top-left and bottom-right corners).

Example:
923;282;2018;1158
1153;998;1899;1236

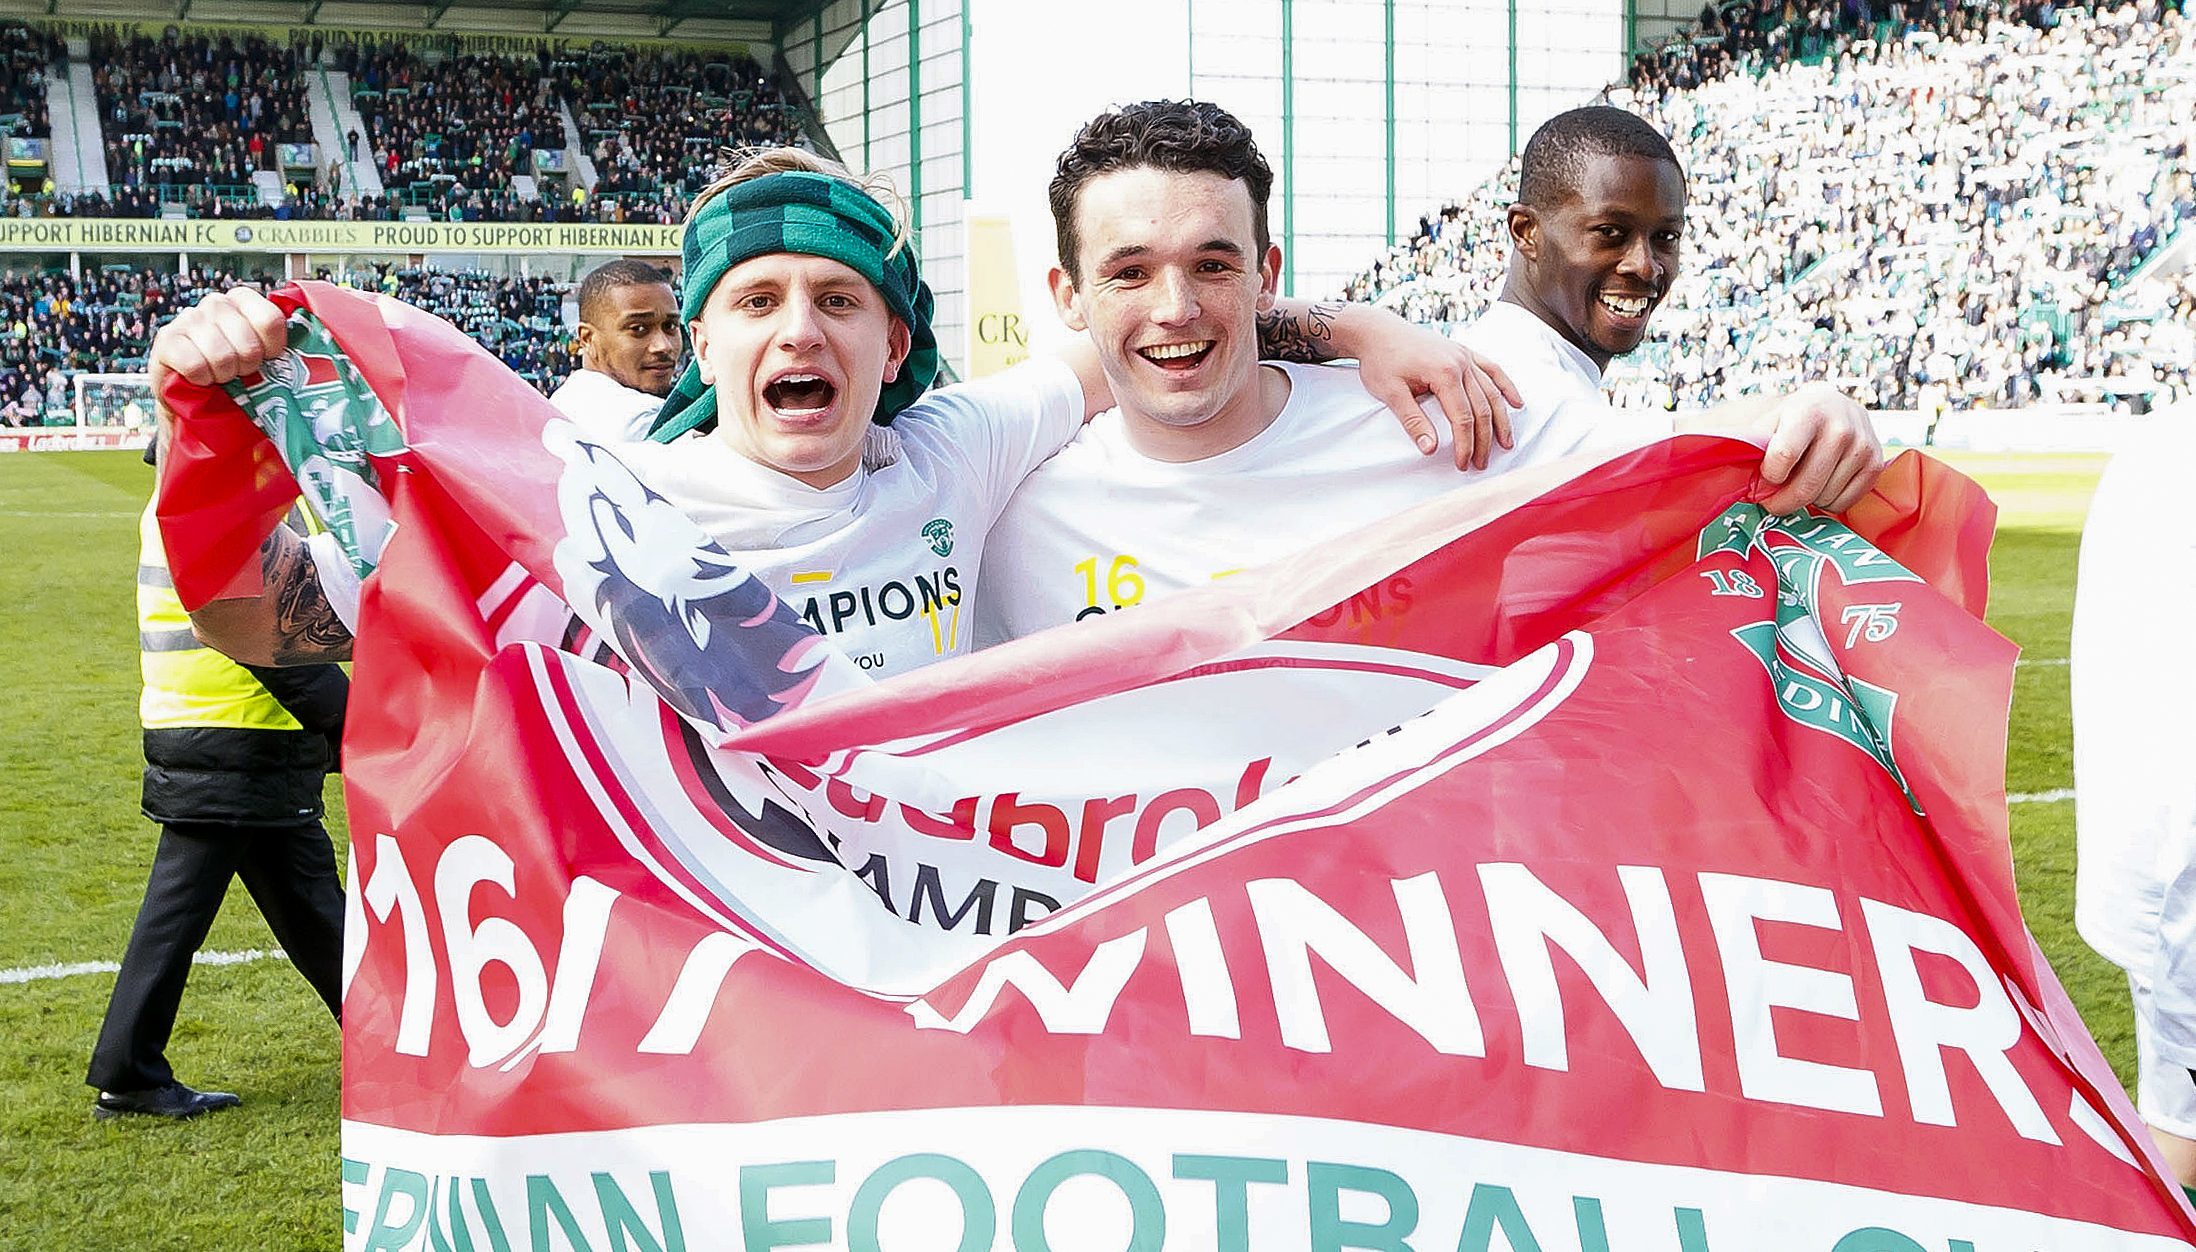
0;24;802;224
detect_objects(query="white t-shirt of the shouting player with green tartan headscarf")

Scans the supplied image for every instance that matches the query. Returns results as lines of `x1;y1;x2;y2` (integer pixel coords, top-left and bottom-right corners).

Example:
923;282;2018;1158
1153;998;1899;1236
617;360;1083;677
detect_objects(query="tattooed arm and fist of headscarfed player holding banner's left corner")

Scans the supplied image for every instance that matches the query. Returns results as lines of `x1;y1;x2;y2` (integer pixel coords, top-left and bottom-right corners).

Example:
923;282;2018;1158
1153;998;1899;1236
149;288;351;666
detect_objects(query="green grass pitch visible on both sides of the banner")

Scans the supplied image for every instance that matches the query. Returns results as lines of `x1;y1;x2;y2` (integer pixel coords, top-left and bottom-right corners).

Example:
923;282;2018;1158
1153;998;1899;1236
0;452;2132;1252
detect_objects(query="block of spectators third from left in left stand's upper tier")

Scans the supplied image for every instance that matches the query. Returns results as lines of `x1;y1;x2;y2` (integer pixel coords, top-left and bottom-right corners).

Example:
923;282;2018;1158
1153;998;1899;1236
336;37;564;202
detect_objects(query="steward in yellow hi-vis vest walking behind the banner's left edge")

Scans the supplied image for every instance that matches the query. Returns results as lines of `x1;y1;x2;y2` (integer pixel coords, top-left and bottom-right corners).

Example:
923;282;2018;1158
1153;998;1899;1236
86;450;349;1118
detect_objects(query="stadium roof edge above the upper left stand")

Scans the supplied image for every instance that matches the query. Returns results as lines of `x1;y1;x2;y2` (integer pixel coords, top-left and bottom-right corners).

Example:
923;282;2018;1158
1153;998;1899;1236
0;0;828;46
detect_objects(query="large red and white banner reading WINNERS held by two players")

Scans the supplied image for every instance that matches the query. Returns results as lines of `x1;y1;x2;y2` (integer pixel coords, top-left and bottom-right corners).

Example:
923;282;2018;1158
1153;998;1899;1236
160;283;2196;1252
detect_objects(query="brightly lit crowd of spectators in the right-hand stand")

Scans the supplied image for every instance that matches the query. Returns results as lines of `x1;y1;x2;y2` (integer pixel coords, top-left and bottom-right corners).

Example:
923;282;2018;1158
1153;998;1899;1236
1348;0;2196;411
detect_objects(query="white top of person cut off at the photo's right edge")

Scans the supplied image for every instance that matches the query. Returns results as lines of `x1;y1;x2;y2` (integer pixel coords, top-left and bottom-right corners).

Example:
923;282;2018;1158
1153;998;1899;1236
2071;420;2196;1065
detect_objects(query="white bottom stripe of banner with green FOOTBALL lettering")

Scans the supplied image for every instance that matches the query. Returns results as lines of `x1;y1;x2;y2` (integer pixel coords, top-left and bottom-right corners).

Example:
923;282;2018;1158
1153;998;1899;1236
340;1096;2187;1252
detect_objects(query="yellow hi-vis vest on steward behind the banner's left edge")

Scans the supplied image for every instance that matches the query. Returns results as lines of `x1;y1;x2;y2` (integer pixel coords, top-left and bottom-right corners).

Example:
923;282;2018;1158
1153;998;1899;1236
138;503;305;729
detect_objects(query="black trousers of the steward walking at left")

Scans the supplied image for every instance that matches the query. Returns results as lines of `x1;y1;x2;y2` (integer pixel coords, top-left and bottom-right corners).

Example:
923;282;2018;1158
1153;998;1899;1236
83;821;343;1092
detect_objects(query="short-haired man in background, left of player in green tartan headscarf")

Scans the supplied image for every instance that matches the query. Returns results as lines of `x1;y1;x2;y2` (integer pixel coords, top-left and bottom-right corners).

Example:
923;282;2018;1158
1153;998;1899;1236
549;257;685;444
